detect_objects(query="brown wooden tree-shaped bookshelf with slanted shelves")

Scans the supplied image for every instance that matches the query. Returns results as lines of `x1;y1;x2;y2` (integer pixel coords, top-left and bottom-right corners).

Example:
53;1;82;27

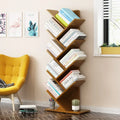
46;10;89;114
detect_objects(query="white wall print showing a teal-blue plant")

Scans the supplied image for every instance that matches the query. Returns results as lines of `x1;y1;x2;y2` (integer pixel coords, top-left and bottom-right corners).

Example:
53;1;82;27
24;12;38;37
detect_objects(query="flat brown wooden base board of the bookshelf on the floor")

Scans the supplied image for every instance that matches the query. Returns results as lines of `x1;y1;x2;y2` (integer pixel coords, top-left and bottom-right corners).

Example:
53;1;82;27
45;108;90;114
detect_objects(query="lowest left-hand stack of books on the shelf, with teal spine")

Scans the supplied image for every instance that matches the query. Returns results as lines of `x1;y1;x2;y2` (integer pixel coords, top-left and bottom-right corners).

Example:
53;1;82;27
47;79;63;98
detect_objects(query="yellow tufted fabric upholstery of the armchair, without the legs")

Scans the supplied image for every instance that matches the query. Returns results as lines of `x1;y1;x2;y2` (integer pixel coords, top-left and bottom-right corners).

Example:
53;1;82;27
0;54;29;95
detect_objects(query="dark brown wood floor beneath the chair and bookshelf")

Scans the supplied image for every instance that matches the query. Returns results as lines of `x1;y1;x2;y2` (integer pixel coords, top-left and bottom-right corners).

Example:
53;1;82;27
0;103;120;120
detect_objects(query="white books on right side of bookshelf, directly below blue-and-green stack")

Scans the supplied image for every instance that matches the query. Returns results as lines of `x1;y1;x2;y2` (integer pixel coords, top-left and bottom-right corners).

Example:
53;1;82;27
60;29;86;47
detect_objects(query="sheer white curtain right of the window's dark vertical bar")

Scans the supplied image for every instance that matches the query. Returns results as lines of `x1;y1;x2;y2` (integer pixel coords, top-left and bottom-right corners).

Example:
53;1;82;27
109;0;120;45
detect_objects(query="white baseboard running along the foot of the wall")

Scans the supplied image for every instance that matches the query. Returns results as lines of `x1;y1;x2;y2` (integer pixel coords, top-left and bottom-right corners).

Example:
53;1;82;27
2;98;120;114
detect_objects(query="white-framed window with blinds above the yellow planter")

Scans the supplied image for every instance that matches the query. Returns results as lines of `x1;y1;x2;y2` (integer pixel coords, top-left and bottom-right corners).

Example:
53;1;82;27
94;0;120;55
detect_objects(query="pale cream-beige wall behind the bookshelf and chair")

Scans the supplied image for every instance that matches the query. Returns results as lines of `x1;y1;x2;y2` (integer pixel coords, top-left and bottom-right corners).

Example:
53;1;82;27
0;0;120;113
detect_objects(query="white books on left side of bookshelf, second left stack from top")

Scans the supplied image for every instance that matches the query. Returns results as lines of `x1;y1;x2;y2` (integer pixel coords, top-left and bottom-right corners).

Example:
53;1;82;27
47;40;63;57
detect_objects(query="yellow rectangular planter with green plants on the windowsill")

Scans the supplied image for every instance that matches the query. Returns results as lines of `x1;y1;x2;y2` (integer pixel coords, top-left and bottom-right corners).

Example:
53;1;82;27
101;43;120;54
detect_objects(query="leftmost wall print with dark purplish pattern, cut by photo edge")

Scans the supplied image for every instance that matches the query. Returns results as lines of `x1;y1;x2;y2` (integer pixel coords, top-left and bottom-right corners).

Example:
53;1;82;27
0;13;6;37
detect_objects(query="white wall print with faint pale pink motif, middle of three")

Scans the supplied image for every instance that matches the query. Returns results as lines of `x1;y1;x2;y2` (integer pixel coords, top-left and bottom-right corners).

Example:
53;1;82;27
8;12;22;37
